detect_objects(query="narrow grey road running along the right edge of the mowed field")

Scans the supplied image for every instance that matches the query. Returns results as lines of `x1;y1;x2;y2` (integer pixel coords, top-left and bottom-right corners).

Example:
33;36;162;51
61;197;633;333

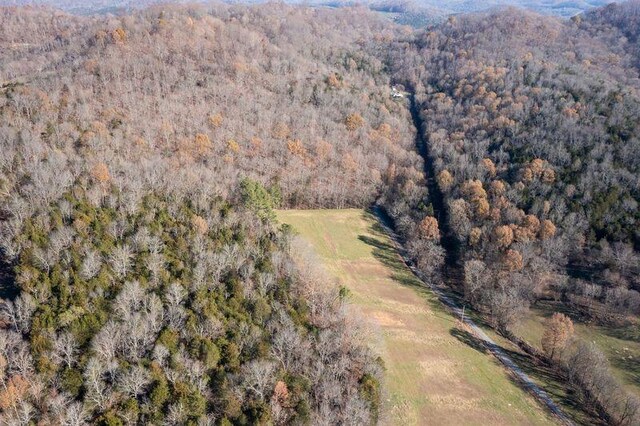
373;206;573;425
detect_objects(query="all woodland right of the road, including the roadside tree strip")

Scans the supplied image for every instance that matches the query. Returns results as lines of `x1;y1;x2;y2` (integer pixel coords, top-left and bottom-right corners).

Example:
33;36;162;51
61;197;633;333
388;2;640;424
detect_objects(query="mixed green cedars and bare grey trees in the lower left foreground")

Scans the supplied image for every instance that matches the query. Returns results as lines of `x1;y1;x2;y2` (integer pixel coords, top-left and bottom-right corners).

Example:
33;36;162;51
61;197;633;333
0;185;381;424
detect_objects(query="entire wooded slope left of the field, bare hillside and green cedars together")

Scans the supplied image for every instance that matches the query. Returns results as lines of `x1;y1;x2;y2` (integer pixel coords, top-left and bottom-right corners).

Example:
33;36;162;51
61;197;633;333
0;6;426;424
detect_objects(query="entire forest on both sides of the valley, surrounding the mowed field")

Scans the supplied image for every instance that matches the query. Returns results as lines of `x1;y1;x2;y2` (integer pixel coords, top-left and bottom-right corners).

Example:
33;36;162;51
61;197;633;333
0;0;640;425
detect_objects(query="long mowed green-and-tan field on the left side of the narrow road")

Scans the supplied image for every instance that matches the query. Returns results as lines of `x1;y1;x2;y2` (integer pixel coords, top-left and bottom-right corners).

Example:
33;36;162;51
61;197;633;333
278;209;554;425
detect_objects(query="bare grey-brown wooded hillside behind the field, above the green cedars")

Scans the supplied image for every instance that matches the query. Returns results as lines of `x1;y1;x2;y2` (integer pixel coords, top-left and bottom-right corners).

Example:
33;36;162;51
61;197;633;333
0;6;419;207
